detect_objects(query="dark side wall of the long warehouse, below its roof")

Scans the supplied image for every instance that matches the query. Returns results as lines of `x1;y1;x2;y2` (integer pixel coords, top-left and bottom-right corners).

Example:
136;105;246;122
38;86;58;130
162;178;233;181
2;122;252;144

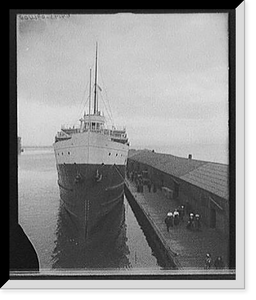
127;159;229;236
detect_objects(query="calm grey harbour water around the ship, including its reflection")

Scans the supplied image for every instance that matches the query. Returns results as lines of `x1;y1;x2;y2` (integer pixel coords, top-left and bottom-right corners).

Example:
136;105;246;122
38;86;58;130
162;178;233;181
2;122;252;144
18;148;161;272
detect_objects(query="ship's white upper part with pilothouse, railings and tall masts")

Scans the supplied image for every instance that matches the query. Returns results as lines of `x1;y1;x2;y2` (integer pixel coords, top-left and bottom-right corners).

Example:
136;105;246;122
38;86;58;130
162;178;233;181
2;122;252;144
54;44;129;165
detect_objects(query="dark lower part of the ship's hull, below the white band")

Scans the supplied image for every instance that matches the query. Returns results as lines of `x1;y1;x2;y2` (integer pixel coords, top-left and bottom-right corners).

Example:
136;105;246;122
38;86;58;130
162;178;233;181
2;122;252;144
57;164;125;246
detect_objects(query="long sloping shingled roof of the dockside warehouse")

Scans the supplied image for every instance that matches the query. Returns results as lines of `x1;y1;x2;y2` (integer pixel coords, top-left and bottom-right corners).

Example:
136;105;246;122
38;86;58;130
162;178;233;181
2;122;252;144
129;150;229;199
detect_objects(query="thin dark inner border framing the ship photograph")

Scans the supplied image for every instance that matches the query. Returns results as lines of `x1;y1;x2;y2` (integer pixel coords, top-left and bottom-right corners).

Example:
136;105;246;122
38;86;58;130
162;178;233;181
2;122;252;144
5;5;242;283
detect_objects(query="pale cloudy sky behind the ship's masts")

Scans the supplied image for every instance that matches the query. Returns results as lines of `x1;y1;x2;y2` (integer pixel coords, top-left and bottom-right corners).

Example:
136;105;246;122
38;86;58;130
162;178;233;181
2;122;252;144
17;13;228;162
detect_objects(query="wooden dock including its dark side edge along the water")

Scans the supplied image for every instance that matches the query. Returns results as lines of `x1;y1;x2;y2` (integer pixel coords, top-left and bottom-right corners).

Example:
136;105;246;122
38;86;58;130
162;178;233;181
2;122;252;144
125;179;229;270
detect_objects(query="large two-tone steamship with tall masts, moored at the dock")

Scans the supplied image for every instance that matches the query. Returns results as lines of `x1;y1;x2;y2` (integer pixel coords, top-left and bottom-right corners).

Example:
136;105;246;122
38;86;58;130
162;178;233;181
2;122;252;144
53;44;129;240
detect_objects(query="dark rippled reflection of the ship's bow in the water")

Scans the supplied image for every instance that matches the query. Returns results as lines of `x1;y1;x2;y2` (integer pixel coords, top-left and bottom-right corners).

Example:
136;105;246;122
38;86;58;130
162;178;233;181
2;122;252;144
52;201;131;269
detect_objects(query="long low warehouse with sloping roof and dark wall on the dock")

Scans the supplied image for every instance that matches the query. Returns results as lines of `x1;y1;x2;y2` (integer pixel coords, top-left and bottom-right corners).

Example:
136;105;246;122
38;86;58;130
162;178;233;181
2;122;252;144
127;150;229;236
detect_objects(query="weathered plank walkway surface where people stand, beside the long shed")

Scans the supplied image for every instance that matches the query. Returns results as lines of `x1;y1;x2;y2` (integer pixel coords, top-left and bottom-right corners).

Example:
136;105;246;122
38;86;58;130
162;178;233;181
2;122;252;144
126;180;229;270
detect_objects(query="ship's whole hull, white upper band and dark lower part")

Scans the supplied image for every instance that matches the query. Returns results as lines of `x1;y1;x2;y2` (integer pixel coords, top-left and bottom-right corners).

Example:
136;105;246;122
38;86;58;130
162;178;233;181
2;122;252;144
54;134;128;247
